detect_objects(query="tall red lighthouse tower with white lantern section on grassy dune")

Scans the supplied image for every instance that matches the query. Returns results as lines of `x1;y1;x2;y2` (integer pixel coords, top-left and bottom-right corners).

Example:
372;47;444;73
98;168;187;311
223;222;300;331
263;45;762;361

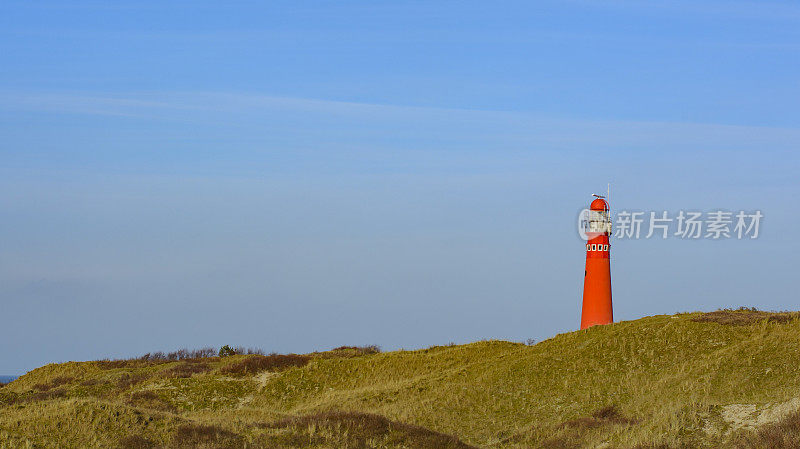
581;195;614;329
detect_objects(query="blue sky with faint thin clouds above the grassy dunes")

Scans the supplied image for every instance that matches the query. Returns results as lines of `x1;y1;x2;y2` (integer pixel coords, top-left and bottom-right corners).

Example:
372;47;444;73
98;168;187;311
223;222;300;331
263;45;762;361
0;0;800;374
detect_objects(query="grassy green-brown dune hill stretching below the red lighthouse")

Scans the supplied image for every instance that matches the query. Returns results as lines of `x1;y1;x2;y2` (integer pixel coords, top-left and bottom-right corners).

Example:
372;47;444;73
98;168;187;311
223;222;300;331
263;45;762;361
0;310;800;449
